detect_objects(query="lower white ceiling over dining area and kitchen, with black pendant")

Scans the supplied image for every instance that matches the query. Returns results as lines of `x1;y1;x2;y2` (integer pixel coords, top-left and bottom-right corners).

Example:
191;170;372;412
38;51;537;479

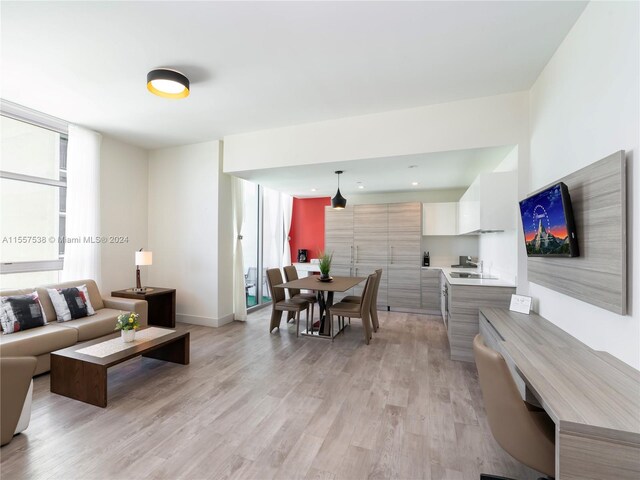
235;145;514;199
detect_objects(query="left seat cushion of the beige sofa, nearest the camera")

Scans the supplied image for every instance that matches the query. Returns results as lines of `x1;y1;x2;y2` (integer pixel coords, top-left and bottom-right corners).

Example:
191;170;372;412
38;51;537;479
0;323;78;357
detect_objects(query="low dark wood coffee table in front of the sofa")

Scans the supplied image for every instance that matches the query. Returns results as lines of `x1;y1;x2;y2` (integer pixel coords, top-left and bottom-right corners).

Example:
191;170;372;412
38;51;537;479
51;327;189;408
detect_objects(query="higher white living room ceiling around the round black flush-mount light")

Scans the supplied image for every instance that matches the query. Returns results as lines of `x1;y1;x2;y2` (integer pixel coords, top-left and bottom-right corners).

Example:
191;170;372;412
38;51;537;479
0;1;586;148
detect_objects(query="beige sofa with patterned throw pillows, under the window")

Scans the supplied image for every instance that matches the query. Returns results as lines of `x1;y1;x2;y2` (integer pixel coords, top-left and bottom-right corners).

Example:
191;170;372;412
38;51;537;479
0;280;147;375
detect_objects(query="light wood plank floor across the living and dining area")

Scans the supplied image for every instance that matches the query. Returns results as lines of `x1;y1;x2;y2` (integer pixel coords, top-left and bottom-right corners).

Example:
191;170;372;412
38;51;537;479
0;310;536;480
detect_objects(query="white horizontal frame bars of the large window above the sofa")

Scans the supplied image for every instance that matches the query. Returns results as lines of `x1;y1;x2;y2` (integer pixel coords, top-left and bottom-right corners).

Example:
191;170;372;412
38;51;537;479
0;99;69;274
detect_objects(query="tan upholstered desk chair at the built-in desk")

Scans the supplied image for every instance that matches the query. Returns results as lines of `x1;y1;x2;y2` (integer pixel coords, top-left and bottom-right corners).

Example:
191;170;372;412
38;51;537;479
473;334;555;480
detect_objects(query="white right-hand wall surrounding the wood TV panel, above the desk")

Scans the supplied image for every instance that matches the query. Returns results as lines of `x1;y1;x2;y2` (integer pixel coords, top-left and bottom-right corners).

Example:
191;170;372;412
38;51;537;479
529;2;640;368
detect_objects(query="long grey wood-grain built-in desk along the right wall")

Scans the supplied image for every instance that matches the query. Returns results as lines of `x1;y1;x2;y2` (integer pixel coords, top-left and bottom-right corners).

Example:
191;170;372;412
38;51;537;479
480;308;640;480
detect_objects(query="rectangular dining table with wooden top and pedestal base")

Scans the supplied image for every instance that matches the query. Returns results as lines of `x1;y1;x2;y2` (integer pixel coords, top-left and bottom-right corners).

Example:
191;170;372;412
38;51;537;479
274;275;367;340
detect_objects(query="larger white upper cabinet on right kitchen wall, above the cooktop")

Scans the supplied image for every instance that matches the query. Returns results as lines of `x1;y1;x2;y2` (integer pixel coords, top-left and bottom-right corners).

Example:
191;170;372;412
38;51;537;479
458;172;518;234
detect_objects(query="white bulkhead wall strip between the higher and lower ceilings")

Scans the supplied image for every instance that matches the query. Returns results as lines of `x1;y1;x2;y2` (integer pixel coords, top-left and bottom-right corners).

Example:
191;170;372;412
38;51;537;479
224;92;528;173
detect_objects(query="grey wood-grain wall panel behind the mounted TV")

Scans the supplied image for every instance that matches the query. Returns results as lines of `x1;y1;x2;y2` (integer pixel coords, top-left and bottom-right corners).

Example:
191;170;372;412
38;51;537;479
527;150;627;315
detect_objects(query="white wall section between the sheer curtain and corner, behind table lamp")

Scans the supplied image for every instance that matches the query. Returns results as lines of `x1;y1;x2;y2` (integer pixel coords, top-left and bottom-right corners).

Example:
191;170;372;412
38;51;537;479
100;135;153;296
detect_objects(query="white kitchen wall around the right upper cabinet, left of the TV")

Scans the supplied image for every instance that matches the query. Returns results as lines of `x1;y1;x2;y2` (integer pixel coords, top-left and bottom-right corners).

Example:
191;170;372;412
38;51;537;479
479;147;526;283
